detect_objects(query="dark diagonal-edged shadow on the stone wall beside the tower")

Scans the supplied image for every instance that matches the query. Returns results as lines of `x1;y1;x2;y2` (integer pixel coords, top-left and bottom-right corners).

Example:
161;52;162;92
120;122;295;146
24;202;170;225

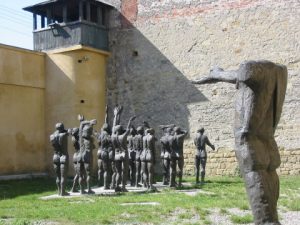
107;15;207;136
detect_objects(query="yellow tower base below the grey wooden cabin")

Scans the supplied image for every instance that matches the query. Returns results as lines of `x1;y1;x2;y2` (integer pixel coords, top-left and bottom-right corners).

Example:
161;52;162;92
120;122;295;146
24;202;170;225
45;46;107;173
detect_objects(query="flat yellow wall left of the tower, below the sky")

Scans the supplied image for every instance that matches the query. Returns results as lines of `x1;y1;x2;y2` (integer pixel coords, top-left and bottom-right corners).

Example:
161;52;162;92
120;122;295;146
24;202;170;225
0;45;46;175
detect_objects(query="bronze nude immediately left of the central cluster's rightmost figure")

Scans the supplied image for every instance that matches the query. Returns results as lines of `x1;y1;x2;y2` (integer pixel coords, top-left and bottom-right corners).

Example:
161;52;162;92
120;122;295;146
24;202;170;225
133;126;144;187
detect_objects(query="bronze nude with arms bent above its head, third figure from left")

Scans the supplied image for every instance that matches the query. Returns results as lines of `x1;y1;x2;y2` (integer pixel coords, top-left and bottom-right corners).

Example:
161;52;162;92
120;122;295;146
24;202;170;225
78;115;97;194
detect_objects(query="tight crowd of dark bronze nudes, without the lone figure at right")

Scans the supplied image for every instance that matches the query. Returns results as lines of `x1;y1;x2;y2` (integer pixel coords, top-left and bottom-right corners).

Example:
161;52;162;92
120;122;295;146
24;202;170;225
50;106;192;195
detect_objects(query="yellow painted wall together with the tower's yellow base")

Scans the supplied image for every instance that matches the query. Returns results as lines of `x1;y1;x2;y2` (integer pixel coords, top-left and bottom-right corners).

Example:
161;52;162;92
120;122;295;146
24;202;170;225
0;45;108;175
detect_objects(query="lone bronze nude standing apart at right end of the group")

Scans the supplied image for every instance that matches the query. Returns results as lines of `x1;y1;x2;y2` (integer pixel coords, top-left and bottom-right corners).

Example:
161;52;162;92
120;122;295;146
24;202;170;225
194;128;215;184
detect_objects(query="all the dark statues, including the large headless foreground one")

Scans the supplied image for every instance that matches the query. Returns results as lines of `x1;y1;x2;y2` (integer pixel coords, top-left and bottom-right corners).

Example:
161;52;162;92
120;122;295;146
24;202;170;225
50;61;287;225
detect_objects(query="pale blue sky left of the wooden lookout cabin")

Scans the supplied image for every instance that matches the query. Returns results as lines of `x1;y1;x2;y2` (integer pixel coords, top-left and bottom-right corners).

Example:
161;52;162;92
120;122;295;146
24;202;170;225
0;0;45;49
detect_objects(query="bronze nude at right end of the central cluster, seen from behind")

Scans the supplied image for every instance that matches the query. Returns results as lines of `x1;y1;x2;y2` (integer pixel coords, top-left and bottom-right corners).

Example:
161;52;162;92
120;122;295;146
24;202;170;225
140;128;156;190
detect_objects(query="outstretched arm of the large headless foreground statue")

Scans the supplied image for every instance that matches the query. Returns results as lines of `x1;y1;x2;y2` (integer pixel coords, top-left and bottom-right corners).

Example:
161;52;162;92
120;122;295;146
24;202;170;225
192;67;238;84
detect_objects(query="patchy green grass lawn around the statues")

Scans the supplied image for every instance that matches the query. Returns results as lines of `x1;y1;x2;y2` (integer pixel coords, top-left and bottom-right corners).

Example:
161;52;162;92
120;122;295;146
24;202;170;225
0;176;300;225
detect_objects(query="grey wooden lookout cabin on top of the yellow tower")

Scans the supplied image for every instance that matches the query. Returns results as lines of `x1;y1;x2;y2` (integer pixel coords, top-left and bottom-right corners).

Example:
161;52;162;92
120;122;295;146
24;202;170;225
24;0;113;51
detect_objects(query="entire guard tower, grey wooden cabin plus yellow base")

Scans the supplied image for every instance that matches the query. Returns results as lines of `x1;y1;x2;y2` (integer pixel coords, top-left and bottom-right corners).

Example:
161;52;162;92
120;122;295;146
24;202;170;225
24;0;113;174
